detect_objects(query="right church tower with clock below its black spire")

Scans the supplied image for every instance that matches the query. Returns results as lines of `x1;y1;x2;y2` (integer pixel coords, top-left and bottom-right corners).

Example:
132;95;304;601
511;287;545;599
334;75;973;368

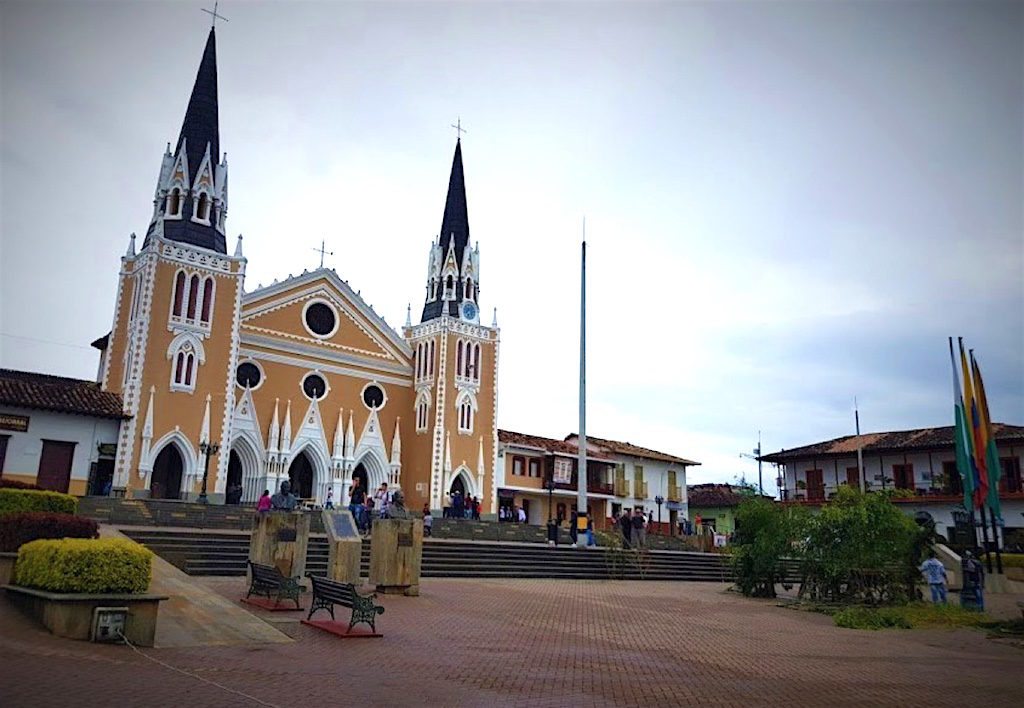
404;139;499;513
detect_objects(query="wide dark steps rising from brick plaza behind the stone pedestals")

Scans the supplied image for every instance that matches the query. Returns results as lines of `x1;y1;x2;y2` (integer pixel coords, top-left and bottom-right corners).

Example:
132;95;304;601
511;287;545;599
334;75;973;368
123;528;732;582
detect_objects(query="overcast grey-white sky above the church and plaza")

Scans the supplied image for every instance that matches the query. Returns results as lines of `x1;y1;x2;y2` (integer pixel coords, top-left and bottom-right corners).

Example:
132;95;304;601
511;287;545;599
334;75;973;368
0;0;1024;487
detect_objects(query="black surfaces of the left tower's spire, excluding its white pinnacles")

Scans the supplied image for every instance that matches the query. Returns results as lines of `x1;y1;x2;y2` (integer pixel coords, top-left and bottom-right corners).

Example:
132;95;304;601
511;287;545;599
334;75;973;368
157;28;227;253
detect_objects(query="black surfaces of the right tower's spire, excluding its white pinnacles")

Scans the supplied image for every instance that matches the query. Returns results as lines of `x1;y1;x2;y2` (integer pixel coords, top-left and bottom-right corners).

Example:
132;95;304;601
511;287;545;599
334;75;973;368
420;139;469;322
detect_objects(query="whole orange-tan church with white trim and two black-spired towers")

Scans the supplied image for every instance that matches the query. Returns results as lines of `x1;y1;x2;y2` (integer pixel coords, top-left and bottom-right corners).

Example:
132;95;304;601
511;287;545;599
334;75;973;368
96;30;499;513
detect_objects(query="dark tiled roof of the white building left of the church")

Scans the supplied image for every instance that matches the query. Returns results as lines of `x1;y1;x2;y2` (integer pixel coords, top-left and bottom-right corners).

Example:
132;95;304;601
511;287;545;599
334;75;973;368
0;369;128;418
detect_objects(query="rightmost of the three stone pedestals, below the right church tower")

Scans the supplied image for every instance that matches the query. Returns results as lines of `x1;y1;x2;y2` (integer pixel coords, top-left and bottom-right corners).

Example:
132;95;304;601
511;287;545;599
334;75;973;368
370;518;423;595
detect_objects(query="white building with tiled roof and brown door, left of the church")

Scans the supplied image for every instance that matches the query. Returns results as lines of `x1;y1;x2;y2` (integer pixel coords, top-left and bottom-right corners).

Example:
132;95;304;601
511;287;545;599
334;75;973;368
0;369;124;496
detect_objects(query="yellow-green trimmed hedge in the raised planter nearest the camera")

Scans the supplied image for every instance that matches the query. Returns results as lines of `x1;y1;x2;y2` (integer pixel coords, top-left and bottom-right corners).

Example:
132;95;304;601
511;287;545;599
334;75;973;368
14;538;153;593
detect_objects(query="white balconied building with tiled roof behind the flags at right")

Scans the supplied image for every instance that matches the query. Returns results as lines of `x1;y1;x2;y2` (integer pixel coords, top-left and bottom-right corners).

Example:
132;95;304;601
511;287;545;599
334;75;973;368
761;423;1024;545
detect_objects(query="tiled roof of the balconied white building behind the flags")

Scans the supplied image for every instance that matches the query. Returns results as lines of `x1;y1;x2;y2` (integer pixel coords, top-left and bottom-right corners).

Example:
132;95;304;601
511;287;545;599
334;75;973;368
761;423;1024;462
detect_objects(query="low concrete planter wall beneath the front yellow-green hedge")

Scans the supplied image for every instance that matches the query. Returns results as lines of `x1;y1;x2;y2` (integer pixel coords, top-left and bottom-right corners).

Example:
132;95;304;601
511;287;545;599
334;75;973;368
3;585;167;647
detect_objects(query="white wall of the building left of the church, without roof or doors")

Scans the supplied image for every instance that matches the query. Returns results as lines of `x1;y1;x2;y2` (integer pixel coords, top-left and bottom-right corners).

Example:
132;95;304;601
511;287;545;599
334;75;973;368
0;407;120;495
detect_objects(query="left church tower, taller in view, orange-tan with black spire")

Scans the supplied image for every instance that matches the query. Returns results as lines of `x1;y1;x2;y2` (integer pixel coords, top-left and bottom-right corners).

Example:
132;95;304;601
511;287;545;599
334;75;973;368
101;29;246;501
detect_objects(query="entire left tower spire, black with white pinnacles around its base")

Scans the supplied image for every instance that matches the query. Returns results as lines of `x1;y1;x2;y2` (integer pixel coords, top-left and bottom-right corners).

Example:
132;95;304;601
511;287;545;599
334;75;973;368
146;28;227;253
